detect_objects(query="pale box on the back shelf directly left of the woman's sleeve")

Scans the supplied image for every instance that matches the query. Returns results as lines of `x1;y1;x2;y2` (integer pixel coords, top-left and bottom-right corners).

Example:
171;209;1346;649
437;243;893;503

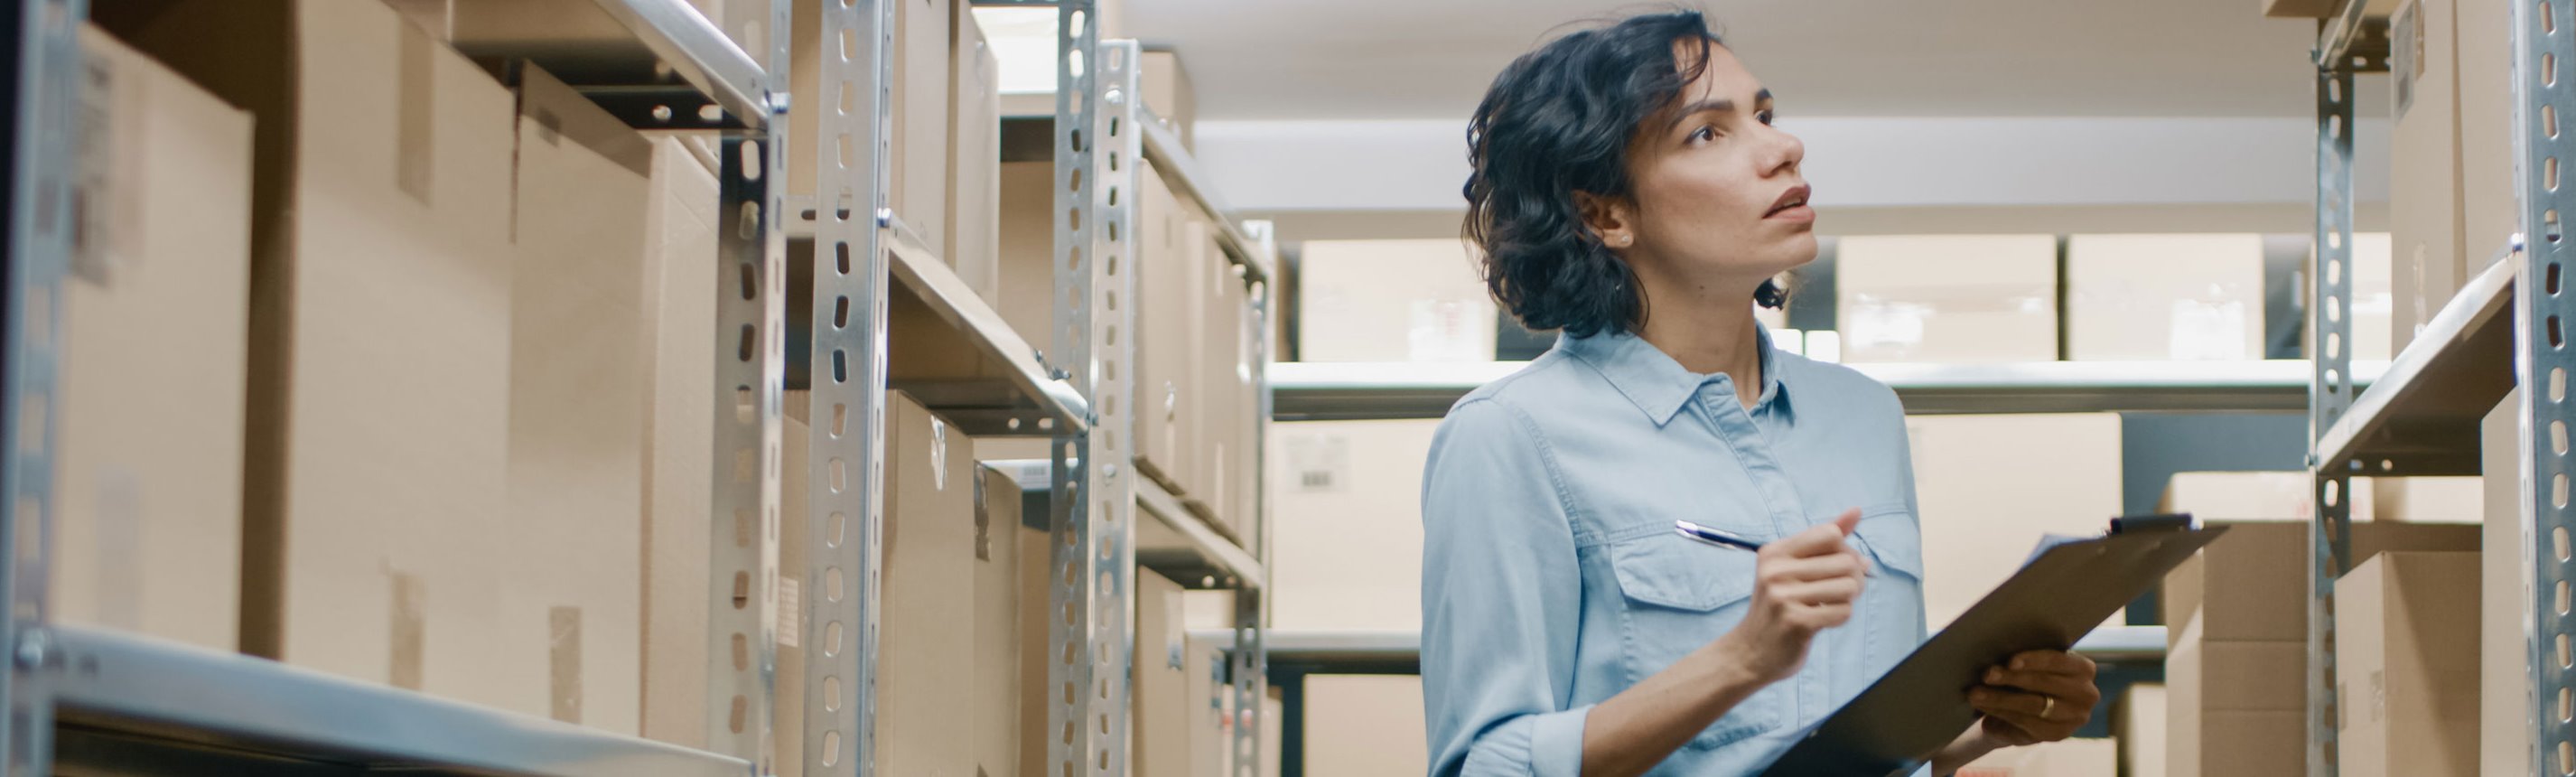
1270;419;1440;631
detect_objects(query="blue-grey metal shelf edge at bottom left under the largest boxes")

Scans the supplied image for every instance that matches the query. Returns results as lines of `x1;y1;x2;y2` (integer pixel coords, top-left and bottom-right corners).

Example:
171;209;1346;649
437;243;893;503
46;628;752;777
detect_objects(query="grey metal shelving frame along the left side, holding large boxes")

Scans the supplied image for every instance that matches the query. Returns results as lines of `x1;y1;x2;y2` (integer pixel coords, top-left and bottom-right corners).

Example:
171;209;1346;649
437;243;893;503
0;0;1275;774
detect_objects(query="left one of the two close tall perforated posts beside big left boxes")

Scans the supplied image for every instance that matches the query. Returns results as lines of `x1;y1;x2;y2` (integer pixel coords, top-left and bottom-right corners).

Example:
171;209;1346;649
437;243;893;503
705;0;793;774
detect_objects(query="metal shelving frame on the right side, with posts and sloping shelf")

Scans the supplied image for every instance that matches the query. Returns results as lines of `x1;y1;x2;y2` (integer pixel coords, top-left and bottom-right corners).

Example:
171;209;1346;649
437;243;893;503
2308;0;2576;777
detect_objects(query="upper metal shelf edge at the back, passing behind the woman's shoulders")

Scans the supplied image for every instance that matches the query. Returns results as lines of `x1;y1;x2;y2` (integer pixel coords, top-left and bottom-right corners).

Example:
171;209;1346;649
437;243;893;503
1273;360;2390;427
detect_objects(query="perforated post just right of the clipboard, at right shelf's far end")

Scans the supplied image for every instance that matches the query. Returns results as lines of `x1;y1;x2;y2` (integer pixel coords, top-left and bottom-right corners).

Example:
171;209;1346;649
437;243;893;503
2308;61;2352;777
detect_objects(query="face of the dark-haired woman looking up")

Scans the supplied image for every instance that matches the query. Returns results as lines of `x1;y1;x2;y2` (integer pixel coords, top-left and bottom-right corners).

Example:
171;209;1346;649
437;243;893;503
1594;42;1816;291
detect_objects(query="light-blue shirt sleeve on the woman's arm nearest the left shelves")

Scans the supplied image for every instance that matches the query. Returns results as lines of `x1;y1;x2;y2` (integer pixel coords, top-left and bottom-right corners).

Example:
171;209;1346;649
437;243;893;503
1422;398;1590;777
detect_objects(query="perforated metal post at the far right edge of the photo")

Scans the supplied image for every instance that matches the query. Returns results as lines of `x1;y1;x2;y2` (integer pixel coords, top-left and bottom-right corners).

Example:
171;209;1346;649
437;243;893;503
2515;0;2576;774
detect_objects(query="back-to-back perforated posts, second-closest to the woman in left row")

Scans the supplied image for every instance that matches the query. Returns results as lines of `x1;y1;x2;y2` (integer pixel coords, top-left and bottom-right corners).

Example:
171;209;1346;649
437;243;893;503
1046;16;1143;777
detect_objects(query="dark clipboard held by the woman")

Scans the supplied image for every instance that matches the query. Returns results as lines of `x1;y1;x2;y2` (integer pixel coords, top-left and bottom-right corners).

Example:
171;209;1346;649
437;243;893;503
1762;515;2226;777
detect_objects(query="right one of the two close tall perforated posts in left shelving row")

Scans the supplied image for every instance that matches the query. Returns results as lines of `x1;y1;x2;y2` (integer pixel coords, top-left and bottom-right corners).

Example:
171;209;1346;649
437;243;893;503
791;0;896;774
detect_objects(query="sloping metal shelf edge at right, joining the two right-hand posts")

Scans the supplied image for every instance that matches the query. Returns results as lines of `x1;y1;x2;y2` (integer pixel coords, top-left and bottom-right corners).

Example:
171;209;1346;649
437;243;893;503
2310;245;2522;463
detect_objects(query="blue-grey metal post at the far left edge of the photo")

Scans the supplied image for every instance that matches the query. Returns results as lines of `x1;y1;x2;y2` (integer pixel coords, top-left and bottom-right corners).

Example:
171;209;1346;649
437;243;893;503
0;0;90;774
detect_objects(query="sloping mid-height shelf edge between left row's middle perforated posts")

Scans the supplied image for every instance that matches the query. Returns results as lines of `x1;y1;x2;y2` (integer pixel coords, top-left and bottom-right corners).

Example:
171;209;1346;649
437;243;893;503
879;216;1089;432
